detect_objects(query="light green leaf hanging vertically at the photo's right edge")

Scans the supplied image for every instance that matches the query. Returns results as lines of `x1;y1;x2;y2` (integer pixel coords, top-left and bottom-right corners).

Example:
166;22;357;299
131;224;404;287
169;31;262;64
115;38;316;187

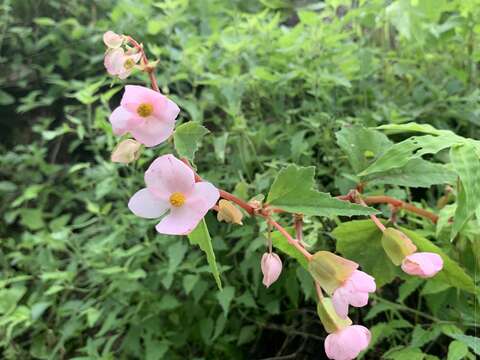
450;143;480;240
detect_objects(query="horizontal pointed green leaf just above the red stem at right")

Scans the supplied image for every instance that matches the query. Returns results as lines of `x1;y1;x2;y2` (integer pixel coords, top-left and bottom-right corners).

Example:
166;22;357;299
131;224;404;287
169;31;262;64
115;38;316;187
366;159;457;187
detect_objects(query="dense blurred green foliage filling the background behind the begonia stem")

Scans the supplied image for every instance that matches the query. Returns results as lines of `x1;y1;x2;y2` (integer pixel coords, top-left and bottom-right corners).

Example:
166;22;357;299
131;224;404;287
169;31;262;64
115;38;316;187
0;0;480;360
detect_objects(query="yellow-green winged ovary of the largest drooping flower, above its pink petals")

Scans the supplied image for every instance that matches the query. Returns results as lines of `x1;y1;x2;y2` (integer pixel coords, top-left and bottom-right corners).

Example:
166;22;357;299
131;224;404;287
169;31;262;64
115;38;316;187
308;251;358;294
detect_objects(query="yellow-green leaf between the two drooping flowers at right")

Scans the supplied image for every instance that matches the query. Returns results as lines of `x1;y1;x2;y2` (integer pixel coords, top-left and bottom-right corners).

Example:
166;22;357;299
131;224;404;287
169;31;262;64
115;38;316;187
332;220;401;287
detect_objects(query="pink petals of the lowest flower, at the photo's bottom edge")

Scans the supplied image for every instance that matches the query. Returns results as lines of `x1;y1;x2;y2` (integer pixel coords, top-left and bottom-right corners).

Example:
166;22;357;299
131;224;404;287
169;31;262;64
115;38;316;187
325;325;371;360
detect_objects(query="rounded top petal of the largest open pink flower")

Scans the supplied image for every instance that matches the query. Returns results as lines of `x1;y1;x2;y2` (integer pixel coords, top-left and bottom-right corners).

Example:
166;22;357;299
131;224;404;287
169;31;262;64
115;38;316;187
145;154;195;201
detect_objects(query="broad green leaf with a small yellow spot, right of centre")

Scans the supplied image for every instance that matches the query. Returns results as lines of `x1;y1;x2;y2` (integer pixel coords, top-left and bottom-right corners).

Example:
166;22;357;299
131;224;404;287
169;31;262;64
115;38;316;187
335;125;393;173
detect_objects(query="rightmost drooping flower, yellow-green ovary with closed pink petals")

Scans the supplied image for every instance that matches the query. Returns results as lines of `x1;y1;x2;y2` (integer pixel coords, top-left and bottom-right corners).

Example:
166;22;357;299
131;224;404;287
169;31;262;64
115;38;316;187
382;228;443;278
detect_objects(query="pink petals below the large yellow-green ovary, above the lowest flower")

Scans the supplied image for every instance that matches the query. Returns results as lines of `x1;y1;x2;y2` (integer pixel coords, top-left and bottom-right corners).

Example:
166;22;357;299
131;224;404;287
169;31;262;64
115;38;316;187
332;270;376;318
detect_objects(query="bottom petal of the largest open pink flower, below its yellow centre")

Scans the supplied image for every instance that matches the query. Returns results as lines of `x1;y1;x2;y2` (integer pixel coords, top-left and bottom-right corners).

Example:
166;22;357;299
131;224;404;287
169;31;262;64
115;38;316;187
155;205;203;235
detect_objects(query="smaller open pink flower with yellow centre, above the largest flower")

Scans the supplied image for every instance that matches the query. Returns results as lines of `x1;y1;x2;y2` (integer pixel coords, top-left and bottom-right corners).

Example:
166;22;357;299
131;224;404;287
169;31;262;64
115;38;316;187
109;85;180;147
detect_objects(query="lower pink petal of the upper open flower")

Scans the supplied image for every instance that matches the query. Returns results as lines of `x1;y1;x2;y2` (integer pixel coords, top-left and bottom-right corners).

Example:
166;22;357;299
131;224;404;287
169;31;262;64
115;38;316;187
130;117;175;147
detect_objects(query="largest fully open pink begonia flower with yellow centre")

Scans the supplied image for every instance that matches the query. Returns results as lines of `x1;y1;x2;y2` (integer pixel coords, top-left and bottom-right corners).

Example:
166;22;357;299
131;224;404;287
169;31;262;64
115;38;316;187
128;154;220;235
